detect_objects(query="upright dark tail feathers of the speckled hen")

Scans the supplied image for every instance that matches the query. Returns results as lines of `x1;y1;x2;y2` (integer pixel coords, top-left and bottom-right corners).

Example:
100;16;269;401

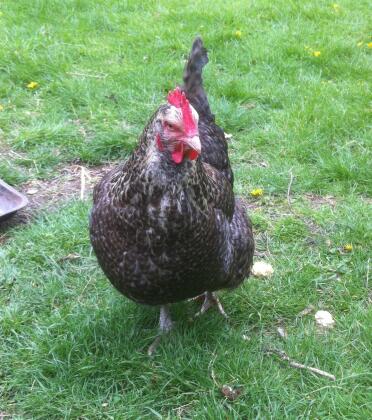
183;37;214;120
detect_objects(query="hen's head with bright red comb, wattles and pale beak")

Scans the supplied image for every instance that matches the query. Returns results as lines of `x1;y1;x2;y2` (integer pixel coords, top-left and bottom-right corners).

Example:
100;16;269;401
156;87;201;164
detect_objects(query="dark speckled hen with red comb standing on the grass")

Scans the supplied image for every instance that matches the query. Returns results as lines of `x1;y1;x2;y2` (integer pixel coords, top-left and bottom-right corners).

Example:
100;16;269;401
90;38;254;353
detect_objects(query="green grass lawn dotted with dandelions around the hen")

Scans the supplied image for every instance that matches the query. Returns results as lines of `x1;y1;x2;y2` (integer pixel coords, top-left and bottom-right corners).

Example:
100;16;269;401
0;0;372;419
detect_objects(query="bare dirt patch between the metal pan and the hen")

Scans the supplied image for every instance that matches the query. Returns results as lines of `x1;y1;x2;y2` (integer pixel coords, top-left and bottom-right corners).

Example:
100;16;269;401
0;164;115;244
